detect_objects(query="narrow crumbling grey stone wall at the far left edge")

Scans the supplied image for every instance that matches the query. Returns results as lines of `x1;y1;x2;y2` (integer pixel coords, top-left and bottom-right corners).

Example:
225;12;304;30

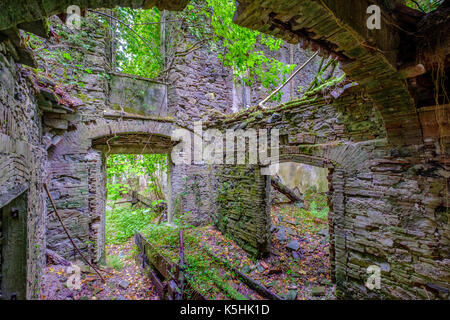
0;40;47;299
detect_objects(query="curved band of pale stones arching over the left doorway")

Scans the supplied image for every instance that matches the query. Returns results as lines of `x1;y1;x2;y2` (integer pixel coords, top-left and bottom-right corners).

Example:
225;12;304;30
51;119;173;158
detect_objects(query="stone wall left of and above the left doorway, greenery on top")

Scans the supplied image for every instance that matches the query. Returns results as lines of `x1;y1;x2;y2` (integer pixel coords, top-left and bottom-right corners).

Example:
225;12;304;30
38;15;173;262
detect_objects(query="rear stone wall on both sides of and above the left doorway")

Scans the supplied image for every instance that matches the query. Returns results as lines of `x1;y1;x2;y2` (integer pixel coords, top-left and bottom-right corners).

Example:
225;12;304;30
40;16;232;261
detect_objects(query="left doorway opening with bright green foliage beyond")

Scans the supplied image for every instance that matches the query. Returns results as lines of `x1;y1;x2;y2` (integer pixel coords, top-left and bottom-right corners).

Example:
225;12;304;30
98;154;169;299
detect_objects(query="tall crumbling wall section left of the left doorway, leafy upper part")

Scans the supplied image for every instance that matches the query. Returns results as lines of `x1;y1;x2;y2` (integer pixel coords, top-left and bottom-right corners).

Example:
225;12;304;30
38;17;109;261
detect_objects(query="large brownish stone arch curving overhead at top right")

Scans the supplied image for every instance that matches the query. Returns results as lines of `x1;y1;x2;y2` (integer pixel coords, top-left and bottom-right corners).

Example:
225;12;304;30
234;0;423;146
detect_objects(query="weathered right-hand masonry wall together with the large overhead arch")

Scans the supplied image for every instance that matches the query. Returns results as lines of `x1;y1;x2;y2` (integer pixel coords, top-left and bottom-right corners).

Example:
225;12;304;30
215;1;450;299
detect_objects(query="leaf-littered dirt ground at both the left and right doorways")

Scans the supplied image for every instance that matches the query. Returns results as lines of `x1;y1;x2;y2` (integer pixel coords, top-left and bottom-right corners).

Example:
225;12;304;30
41;205;335;300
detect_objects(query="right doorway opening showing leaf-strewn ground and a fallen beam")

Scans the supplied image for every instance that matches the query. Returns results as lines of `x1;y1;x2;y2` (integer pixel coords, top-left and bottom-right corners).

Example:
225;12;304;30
270;162;335;299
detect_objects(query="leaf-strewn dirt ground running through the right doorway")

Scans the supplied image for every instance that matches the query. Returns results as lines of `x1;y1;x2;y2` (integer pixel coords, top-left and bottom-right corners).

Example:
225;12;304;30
197;205;335;300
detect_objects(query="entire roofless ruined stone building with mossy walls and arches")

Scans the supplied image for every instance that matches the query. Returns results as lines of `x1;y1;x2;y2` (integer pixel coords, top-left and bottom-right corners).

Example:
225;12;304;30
0;0;450;299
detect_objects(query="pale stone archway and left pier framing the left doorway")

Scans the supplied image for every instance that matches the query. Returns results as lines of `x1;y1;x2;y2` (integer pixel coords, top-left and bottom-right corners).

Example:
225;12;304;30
47;119;174;262
